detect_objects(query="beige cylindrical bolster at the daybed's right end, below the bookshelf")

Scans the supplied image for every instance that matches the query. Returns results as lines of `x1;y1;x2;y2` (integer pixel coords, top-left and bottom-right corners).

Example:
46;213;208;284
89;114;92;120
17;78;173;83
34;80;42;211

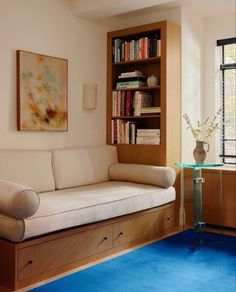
109;163;175;188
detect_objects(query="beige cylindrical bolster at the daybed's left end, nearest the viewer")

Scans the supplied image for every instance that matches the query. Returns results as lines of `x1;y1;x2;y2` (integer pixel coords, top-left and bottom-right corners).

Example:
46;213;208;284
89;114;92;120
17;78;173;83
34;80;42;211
0;180;40;219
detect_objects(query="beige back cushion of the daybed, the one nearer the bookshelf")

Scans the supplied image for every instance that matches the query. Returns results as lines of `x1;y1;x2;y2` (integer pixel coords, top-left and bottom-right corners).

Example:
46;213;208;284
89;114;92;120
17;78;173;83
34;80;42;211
52;145;117;189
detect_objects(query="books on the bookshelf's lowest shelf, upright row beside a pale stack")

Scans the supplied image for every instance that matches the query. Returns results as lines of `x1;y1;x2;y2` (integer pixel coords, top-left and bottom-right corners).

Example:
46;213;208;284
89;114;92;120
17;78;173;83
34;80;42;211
111;119;160;145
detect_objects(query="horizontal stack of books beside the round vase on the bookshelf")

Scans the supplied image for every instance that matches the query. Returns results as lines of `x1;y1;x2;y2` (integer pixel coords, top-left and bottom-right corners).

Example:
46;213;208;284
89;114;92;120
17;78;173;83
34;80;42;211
116;71;147;89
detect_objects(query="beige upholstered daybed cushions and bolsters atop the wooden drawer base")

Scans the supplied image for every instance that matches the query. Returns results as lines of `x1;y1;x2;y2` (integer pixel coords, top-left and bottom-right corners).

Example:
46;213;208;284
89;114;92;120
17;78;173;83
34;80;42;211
0;146;175;242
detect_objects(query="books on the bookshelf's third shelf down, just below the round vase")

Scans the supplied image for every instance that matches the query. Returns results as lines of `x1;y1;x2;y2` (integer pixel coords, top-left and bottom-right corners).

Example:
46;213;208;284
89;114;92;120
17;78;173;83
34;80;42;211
112;90;161;117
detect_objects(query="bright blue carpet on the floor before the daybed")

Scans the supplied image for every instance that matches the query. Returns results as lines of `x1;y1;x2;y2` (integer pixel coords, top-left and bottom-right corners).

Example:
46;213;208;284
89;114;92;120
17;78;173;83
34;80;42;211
31;230;236;292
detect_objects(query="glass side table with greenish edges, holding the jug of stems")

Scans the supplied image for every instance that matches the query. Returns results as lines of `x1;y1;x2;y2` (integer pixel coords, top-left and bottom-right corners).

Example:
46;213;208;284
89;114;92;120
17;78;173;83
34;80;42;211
176;163;223;244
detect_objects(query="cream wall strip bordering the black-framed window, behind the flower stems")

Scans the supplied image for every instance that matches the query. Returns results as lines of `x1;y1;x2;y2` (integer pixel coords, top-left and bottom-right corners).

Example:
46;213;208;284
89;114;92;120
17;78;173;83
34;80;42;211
203;13;236;162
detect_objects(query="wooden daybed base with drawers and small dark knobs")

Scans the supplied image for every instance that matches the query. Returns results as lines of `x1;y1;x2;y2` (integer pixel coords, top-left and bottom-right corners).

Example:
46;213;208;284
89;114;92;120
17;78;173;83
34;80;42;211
0;203;175;291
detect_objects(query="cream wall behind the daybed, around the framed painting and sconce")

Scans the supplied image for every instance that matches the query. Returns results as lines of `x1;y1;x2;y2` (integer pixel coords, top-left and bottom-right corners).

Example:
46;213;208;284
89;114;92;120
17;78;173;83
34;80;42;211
0;0;106;149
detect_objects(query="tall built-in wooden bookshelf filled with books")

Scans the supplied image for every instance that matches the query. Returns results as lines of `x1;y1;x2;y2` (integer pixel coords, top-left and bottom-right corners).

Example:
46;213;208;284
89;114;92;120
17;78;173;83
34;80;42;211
107;21;180;165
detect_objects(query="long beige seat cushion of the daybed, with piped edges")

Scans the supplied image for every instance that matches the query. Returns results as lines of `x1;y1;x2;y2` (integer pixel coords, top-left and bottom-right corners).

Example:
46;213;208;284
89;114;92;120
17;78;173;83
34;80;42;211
0;181;175;241
